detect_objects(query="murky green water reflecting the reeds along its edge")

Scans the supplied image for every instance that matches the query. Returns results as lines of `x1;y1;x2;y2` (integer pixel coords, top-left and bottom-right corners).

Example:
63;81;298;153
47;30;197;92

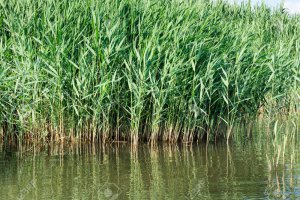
0;143;300;200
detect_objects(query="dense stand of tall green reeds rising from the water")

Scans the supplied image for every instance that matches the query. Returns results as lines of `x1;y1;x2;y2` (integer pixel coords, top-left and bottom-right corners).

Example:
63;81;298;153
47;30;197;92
0;0;300;144
